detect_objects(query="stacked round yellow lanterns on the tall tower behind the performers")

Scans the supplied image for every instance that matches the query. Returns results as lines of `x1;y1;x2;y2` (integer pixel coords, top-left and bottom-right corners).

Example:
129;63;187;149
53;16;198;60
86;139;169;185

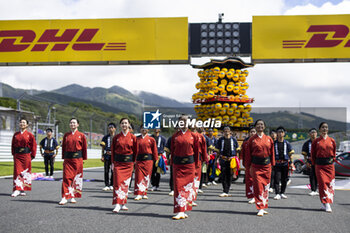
192;66;253;131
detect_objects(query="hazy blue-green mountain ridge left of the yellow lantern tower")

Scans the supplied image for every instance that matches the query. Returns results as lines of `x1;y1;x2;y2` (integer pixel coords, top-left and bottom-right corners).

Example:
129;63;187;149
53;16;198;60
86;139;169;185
2;84;193;114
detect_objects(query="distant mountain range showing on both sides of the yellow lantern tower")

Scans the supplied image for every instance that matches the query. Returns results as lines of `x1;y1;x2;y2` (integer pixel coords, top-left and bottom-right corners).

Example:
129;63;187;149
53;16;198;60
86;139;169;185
2;84;348;131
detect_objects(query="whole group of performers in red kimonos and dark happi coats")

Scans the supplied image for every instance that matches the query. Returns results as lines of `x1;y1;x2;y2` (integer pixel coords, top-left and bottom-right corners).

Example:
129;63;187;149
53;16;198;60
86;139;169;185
11;115;336;220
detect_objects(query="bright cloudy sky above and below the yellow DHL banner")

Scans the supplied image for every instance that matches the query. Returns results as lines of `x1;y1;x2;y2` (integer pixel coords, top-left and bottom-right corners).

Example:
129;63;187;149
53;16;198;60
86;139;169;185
0;0;350;121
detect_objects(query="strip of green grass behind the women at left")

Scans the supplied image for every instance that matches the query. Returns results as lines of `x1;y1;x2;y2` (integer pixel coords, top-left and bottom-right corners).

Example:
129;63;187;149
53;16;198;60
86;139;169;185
0;159;103;176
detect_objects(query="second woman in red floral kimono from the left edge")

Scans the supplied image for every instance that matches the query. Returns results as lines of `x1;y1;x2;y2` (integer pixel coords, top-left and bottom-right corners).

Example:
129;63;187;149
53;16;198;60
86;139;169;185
58;117;87;205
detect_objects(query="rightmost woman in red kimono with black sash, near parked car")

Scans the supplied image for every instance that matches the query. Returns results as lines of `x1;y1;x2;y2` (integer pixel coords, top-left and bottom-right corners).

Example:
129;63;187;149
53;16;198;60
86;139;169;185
311;122;336;213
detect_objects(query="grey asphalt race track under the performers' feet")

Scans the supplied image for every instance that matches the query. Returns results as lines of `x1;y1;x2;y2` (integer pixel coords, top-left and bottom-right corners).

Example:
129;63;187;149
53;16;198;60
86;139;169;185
0;168;350;233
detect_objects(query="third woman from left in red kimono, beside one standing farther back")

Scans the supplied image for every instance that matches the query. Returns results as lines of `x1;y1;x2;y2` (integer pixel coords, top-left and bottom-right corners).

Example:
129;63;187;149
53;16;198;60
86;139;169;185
111;118;138;213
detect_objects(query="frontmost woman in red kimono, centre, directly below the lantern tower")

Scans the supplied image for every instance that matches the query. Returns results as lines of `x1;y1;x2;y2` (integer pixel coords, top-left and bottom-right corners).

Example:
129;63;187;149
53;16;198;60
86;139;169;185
170;116;199;220
